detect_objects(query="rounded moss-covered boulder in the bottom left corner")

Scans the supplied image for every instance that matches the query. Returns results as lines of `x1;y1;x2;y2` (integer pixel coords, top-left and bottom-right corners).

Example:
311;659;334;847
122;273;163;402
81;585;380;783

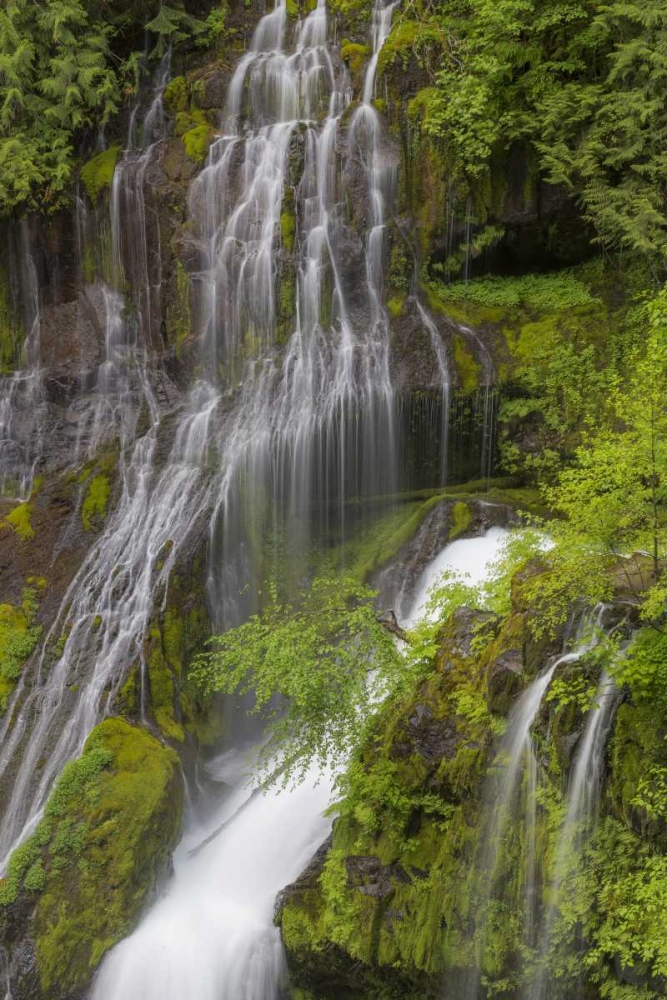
0;718;183;1000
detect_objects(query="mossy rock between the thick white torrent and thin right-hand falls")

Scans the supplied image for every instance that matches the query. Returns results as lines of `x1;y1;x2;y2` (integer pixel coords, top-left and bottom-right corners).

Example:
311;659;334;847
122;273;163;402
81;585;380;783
278;608;544;1000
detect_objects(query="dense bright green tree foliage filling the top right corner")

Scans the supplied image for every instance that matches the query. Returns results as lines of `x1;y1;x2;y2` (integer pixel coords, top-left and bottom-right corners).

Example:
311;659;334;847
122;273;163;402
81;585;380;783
395;0;667;253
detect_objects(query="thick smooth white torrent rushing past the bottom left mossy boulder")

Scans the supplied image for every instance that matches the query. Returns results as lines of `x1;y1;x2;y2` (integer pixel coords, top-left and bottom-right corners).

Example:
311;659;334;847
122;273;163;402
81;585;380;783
92;761;331;1000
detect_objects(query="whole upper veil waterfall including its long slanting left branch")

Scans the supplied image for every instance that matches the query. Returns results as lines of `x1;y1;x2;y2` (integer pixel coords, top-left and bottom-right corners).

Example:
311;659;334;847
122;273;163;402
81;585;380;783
0;0;418;880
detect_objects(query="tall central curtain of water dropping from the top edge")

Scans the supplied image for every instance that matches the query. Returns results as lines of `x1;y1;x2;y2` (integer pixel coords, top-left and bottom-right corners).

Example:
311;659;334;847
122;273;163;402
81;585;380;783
190;2;408;607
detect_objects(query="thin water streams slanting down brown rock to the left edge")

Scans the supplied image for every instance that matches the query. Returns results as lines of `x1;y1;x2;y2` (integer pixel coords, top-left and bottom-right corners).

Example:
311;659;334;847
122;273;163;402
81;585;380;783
0;64;181;869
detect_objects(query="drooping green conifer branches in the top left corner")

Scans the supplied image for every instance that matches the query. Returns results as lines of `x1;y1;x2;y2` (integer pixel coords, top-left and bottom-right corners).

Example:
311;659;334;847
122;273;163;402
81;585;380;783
0;0;205;214
